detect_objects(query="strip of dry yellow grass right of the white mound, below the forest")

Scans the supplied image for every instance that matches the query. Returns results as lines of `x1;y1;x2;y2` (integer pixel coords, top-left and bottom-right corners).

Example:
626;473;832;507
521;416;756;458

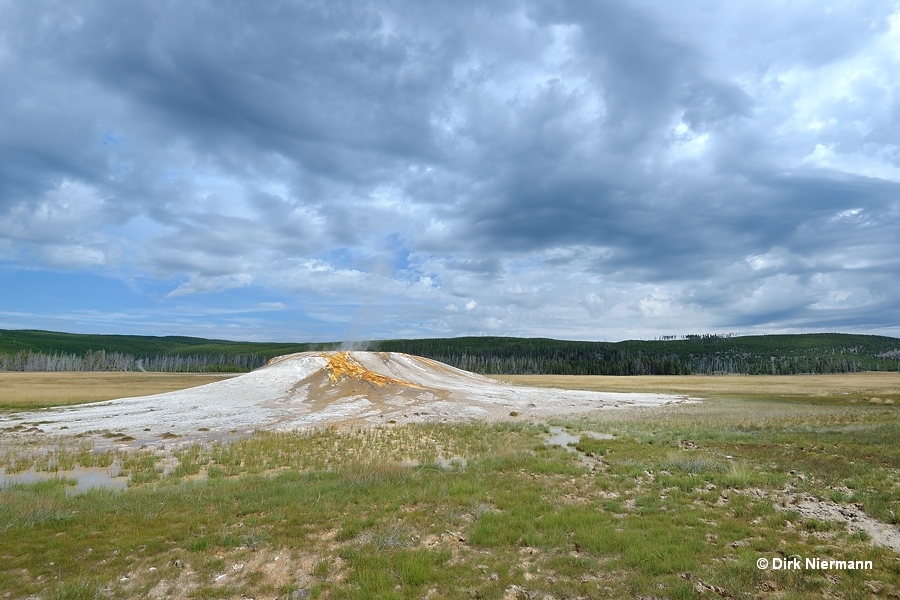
495;372;900;404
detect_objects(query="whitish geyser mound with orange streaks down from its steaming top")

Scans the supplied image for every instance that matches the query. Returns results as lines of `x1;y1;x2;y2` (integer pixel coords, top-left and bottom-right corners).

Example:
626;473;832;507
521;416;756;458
0;352;686;444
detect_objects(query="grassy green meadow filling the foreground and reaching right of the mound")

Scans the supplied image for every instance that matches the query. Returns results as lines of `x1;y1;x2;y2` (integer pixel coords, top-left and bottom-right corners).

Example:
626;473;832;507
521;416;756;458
0;373;900;600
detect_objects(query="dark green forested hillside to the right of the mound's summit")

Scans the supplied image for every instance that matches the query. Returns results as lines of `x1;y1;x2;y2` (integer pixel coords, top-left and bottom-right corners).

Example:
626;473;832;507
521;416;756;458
373;334;900;375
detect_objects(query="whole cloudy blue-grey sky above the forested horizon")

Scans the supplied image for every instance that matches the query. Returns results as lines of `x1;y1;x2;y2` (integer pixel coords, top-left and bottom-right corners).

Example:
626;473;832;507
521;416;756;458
0;0;900;342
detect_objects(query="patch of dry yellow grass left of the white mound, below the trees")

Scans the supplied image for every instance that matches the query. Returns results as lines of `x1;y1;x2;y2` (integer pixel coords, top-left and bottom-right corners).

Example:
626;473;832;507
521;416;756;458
0;372;233;409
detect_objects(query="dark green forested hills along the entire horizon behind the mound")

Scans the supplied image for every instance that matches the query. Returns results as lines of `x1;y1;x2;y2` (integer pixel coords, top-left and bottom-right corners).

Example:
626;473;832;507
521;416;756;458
0;330;900;375
